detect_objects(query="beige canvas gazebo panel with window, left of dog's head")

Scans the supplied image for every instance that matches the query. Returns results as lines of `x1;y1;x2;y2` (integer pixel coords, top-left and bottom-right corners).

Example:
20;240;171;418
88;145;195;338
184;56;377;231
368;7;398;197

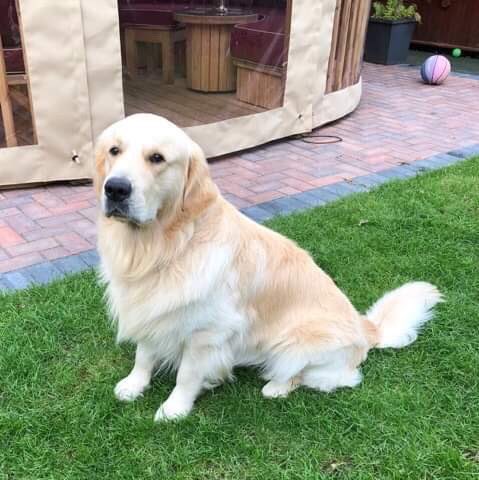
0;0;92;187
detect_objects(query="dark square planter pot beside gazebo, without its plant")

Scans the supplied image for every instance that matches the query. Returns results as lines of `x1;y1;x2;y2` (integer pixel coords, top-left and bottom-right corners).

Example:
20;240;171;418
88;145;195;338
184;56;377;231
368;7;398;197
364;18;417;65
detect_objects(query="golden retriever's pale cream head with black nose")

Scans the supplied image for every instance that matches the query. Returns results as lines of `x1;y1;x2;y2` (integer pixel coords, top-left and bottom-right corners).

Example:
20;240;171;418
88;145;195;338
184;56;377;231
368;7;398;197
95;114;204;225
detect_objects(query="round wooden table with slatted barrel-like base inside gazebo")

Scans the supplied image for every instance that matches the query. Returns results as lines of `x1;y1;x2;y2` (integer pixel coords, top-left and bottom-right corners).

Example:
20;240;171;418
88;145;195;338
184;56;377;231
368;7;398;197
175;8;258;92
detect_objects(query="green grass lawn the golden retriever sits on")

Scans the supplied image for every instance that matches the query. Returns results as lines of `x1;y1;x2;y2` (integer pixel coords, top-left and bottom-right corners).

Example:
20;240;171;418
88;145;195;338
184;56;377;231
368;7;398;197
0;159;479;480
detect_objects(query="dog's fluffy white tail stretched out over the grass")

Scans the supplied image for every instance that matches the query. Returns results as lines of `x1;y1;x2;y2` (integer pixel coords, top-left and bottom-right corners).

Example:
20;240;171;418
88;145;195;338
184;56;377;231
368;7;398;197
366;282;443;348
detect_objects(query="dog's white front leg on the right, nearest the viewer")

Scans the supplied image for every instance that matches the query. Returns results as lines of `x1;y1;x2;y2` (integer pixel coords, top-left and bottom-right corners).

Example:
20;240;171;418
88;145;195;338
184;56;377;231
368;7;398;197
155;337;231;421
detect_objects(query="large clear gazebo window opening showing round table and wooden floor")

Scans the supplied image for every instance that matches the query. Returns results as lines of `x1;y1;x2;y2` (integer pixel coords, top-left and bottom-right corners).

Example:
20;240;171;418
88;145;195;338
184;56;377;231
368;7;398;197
118;0;290;127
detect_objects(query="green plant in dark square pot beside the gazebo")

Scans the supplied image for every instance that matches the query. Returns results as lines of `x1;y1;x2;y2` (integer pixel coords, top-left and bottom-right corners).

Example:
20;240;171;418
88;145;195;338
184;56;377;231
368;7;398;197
364;0;421;65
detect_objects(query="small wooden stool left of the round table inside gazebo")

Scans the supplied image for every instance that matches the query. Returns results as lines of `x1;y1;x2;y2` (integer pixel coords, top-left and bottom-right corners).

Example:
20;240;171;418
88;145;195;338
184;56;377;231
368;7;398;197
125;26;185;84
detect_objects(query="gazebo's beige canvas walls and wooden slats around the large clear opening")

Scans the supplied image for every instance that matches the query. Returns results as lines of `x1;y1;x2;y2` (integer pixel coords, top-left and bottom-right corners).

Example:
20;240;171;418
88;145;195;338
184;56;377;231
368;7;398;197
0;0;370;186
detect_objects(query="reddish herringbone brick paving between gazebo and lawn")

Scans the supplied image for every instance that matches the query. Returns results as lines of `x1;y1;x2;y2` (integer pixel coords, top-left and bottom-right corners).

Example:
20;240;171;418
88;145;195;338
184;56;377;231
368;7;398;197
0;65;479;287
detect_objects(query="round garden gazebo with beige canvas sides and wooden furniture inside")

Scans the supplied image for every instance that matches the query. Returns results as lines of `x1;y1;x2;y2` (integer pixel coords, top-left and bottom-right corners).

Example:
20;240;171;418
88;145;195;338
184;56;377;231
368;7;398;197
0;0;370;186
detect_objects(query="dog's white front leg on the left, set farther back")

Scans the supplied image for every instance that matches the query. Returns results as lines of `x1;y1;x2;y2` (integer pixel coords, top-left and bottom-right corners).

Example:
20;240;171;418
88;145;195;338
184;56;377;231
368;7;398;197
115;343;156;402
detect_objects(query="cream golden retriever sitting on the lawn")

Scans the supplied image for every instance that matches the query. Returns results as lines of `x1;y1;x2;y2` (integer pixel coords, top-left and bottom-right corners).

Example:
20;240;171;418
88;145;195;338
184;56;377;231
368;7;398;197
95;114;441;421
